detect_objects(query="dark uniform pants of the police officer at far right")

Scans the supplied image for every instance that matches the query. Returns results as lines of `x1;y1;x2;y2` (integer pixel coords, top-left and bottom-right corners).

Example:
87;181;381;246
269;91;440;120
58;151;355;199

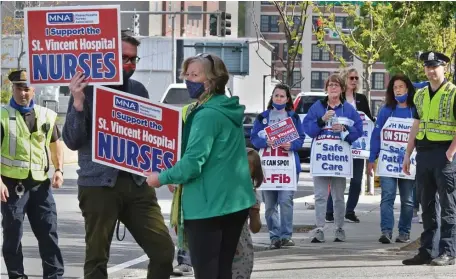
416;148;456;257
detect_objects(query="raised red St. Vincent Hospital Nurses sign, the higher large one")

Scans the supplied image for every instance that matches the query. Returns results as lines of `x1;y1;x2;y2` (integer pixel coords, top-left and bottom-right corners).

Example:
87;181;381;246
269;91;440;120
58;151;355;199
24;5;123;85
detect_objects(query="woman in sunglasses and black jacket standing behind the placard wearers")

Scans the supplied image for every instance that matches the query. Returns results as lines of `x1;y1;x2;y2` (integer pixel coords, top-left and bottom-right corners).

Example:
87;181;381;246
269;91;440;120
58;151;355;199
326;67;375;223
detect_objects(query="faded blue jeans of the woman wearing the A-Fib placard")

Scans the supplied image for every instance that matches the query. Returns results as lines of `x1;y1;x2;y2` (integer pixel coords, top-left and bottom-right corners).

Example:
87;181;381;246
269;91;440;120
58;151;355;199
262;190;295;240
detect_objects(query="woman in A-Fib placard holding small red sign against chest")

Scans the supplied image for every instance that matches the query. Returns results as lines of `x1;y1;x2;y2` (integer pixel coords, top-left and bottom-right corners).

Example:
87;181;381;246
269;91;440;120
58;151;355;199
250;84;305;249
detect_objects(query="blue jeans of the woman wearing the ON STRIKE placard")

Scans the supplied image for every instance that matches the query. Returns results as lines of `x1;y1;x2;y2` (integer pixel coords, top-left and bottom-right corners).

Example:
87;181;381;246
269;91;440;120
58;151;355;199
380;177;415;234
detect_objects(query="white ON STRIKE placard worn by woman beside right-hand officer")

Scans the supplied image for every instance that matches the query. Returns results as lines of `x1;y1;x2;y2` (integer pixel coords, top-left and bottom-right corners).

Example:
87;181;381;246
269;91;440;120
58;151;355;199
377;117;416;179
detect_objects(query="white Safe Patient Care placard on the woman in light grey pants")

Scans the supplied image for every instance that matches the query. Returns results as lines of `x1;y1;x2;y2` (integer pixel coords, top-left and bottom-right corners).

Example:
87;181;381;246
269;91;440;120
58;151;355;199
310;117;353;178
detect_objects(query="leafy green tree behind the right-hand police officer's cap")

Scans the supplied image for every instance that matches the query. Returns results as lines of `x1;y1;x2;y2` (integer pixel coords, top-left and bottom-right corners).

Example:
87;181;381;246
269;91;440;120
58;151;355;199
381;2;456;81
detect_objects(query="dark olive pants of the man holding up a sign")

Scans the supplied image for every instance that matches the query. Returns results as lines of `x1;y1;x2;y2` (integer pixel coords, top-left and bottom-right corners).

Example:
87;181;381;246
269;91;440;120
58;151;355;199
78;173;174;279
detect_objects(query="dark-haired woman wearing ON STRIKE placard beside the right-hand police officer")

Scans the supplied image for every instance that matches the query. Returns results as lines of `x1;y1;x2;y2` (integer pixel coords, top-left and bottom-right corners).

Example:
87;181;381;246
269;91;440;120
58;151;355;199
367;74;416;244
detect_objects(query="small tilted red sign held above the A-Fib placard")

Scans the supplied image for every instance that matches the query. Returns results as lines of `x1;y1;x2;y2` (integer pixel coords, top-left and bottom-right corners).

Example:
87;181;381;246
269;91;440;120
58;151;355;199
264;117;299;148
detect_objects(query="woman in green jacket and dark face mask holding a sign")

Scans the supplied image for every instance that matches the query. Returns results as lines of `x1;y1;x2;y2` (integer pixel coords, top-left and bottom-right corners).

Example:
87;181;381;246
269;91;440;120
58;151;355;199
147;54;256;279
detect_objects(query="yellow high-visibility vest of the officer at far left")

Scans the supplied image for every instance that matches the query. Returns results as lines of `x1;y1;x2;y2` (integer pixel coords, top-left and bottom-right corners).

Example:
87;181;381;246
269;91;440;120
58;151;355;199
1;105;57;181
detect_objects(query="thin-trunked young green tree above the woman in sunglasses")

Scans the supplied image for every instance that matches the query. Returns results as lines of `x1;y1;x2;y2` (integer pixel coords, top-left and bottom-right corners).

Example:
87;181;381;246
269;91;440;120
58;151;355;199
314;1;410;103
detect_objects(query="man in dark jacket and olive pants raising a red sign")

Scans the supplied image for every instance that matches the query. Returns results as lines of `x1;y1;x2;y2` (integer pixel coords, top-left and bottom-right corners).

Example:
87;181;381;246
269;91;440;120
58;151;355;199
63;30;174;279
